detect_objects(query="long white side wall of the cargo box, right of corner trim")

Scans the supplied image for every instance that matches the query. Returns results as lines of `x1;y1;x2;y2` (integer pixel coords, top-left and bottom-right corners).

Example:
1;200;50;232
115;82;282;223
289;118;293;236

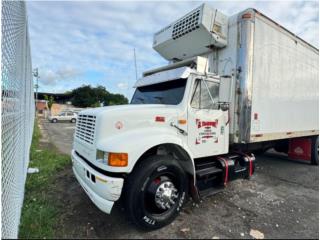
250;14;319;142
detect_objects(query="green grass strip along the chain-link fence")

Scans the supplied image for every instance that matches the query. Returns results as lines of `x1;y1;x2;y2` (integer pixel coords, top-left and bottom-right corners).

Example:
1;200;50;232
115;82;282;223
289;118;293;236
19;119;70;239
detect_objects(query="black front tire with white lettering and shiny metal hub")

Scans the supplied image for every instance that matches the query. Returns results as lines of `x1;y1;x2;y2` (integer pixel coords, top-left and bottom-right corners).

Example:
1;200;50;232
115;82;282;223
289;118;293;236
124;155;188;230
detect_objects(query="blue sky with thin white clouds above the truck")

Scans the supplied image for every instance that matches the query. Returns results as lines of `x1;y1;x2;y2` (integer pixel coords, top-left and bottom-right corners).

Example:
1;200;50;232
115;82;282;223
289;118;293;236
27;1;319;98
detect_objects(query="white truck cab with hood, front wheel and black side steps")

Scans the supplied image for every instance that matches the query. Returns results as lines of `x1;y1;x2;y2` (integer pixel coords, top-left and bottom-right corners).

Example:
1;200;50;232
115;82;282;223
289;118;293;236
72;63;254;228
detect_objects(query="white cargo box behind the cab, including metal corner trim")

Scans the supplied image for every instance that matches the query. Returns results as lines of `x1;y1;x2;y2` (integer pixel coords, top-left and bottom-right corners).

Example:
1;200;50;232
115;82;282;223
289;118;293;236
215;9;319;143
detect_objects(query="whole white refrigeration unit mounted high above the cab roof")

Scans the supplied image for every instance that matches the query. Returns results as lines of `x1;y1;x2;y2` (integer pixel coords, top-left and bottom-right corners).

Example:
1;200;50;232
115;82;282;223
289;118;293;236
153;4;228;61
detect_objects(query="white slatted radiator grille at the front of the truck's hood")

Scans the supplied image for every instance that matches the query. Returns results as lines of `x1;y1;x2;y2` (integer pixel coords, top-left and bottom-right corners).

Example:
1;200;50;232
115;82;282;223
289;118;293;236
75;114;96;144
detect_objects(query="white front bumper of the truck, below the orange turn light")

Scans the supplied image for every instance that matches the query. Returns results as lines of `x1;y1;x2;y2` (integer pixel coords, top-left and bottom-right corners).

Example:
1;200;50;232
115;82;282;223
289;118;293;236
71;150;123;214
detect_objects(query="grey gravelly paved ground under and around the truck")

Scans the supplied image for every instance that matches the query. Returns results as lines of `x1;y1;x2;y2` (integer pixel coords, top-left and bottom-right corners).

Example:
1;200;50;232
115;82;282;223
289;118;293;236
42;119;319;239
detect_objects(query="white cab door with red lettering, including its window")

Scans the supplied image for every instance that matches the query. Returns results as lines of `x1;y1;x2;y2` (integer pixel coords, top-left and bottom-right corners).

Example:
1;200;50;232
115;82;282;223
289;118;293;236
188;79;229;158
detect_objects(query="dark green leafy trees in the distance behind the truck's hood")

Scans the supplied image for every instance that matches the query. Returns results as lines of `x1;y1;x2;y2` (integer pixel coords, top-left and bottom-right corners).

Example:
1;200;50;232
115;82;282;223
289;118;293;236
72;85;128;107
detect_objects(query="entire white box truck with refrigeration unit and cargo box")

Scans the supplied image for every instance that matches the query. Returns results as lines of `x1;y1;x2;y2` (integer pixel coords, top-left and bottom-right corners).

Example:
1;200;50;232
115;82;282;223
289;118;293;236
72;4;319;229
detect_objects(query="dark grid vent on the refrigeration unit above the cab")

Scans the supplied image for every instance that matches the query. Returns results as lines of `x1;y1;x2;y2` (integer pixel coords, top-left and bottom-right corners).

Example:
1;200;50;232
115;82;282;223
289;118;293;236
172;9;200;39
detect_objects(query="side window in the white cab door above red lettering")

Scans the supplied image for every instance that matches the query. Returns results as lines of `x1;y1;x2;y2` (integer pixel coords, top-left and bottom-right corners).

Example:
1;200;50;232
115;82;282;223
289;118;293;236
191;80;219;109
